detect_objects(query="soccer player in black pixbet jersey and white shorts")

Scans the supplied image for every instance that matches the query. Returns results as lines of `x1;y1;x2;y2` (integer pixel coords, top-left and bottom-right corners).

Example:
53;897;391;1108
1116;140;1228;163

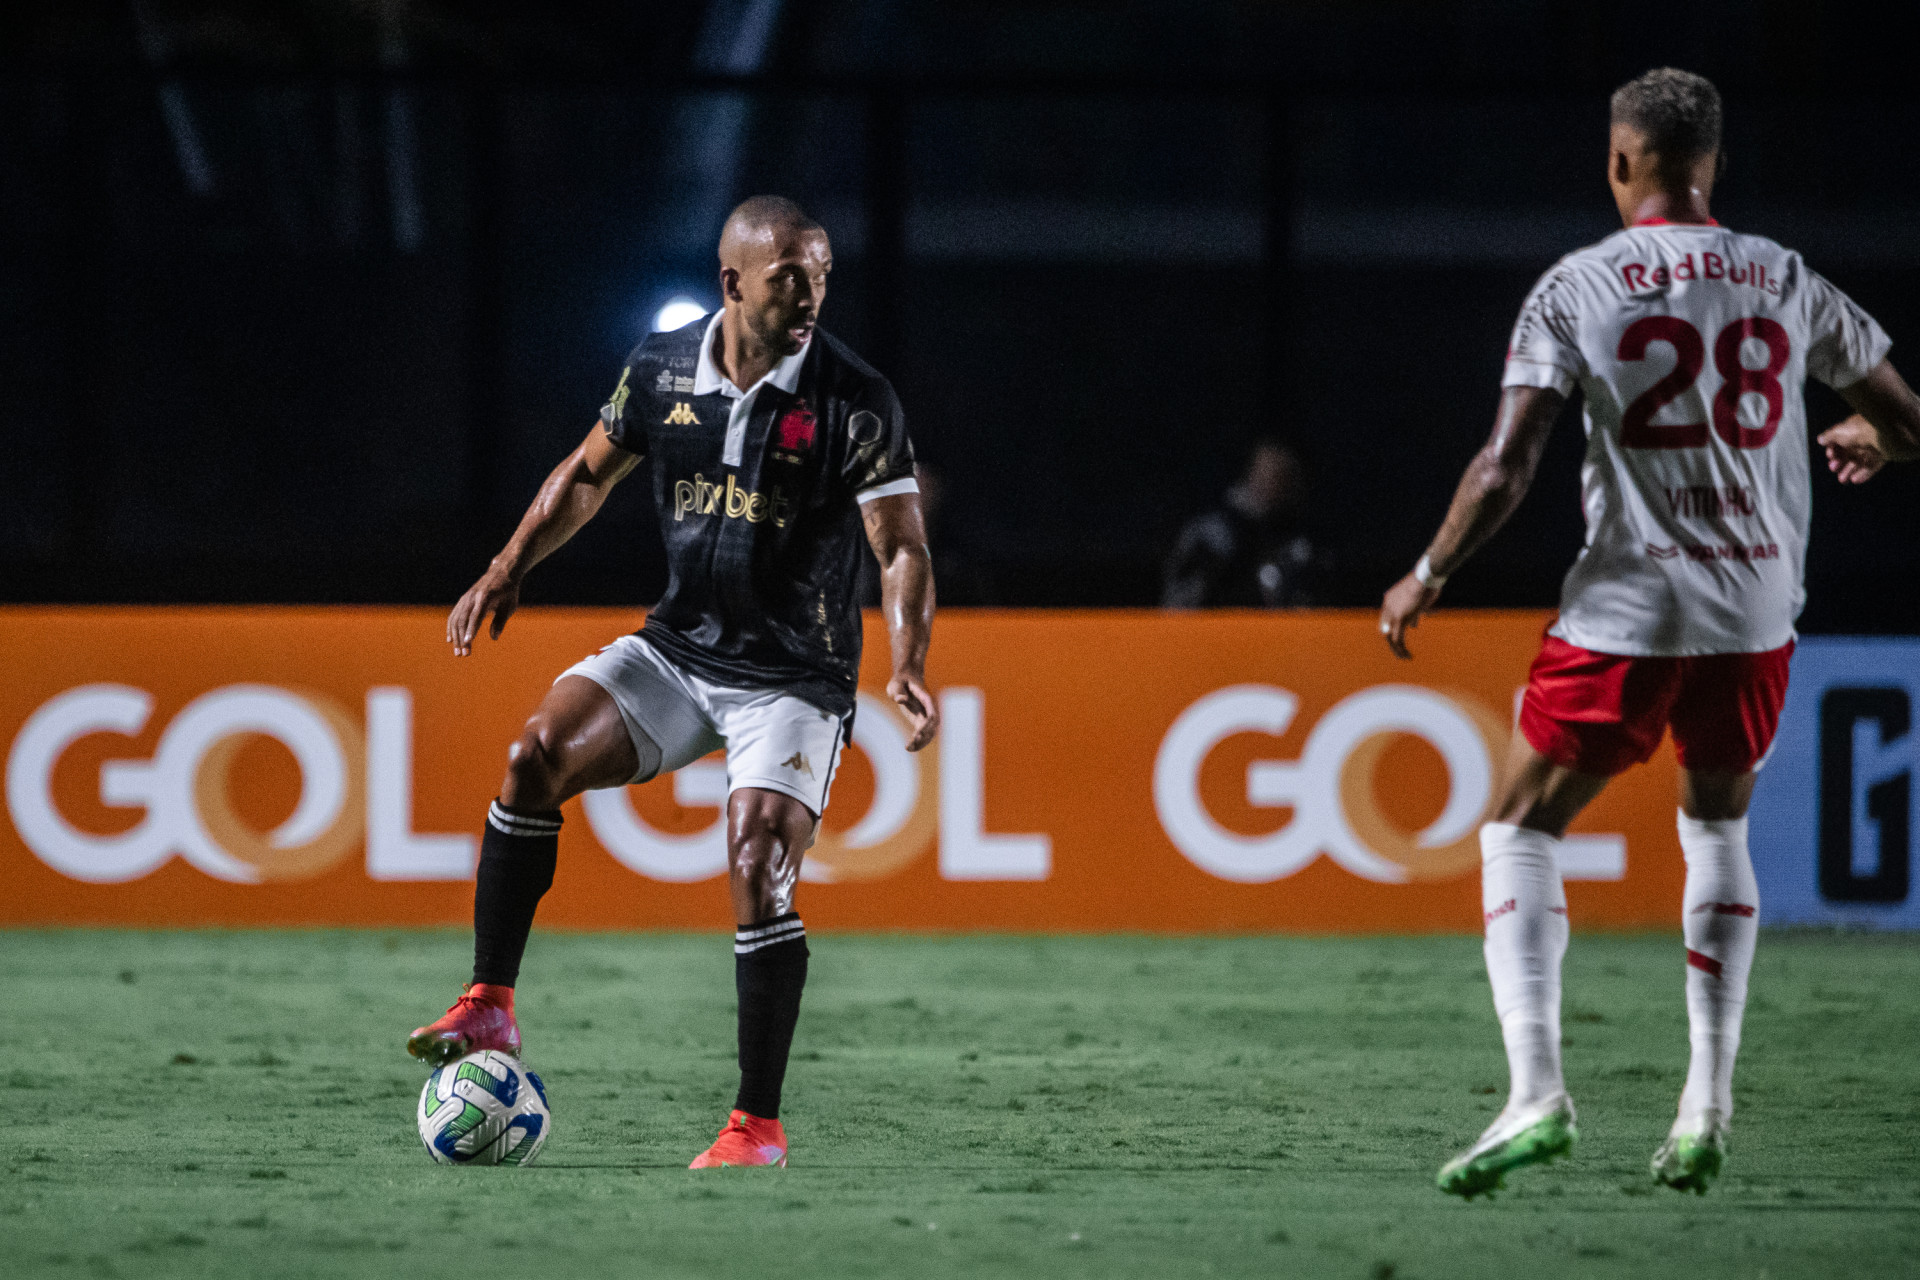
407;196;939;1169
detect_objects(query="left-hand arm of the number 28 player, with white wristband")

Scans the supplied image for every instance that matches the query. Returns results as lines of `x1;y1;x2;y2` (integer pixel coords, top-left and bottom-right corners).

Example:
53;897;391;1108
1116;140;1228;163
1380;386;1567;658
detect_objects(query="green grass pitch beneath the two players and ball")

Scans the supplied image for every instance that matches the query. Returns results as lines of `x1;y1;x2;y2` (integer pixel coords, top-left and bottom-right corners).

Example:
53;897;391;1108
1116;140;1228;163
0;931;1920;1280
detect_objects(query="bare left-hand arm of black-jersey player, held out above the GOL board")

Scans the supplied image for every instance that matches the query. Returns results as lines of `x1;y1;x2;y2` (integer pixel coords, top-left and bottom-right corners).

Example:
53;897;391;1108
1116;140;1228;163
447;422;639;658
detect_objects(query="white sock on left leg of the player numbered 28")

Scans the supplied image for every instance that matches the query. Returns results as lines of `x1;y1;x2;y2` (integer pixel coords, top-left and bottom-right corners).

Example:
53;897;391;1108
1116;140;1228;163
1480;821;1567;1107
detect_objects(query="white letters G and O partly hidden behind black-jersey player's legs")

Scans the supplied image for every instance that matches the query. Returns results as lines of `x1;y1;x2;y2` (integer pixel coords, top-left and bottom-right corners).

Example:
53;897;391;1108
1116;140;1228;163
582;693;920;885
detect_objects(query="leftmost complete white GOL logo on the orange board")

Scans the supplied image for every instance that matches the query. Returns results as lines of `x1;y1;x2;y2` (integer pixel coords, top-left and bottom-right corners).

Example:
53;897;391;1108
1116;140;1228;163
6;685;476;885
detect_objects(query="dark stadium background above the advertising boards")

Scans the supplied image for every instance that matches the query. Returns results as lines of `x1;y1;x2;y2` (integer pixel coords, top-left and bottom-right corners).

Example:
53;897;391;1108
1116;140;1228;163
0;0;1920;631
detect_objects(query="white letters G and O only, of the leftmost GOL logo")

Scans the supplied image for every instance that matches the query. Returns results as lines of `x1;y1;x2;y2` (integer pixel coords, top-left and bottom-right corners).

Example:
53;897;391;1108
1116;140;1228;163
6;685;348;885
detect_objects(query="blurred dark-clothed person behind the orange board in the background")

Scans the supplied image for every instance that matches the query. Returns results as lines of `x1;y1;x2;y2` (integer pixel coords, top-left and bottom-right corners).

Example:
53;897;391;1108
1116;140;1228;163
1159;438;1325;608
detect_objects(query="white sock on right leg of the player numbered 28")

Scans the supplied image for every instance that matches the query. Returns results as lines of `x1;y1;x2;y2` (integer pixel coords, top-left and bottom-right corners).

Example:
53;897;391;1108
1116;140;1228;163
1680;814;1761;1125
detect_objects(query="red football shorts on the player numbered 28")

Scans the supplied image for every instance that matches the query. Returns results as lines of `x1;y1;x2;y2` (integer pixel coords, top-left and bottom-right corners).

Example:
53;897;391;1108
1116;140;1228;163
1521;635;1793;777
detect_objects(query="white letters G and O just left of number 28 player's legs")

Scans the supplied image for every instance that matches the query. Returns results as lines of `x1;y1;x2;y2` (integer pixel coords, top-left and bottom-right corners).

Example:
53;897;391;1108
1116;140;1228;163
1154;685;1494;885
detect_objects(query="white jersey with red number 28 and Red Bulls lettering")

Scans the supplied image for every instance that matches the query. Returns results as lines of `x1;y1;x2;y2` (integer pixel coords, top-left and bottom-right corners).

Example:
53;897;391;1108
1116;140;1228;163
1501;223;1891;656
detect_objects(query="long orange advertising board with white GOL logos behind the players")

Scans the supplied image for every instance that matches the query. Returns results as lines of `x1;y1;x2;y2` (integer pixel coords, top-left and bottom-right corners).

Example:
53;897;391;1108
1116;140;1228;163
0;608;1684;933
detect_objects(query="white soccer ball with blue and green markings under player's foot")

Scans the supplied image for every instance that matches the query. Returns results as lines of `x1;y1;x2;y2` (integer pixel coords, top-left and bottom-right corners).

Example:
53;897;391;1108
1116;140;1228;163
417;1050;553;1165
